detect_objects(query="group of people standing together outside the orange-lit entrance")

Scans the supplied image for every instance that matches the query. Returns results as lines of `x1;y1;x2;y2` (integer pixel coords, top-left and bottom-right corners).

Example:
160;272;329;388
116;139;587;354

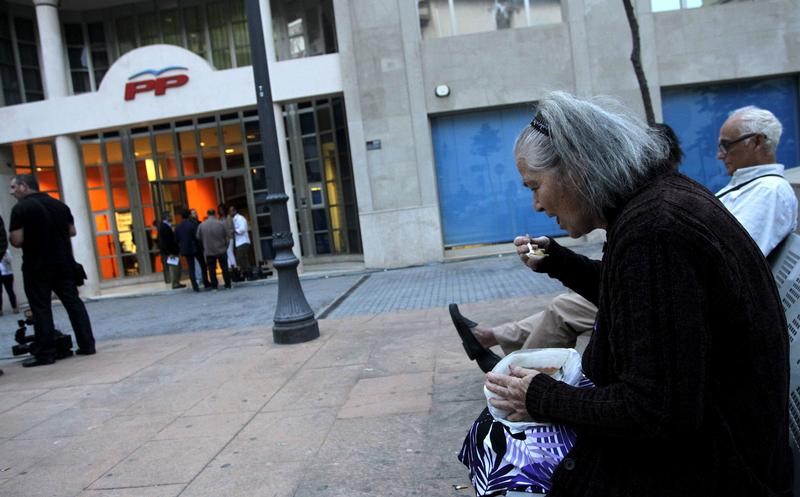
158;204;251;292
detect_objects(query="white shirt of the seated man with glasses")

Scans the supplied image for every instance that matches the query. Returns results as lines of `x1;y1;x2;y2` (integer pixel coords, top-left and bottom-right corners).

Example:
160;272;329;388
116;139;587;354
717;164;797;255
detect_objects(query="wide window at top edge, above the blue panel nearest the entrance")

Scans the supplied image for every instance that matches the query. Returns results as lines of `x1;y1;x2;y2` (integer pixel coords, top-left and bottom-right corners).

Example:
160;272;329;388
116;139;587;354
417;0;562;38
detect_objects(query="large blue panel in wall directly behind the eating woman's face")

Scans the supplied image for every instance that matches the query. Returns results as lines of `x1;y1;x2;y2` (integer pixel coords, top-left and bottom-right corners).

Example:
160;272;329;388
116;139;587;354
431;106;564;247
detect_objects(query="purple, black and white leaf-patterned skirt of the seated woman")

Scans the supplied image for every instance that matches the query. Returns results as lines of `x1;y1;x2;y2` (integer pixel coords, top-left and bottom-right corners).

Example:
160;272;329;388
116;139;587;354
458;377;593;497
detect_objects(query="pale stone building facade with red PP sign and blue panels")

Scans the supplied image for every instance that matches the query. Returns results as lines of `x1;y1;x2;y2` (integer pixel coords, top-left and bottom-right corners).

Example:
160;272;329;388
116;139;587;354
0;0;800;293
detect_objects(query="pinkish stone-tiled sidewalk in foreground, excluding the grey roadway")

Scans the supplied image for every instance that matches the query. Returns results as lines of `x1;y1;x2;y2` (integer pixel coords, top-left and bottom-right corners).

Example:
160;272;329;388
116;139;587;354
0;297;560;497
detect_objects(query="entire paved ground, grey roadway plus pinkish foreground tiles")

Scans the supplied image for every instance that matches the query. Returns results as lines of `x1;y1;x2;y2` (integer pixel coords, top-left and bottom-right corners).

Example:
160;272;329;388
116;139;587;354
0;244;600;497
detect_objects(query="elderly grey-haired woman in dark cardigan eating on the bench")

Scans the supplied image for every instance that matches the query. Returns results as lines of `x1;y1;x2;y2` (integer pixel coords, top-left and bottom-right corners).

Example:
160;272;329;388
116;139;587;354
461;93;792;497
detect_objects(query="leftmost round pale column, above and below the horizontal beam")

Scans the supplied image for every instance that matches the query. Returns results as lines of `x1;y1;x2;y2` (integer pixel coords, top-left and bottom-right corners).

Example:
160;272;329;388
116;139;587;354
33;0;100;296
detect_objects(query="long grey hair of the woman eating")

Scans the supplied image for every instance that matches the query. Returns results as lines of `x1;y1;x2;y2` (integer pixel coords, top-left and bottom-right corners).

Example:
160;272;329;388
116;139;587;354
514;92;668;215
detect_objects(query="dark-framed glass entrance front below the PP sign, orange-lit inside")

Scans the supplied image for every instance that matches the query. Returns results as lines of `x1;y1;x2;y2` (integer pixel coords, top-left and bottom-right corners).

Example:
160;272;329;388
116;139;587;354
78;104;361;280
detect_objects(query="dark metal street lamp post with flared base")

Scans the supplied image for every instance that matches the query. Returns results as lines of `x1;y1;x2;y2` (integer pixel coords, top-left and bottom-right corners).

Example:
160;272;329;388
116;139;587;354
246;0;319;343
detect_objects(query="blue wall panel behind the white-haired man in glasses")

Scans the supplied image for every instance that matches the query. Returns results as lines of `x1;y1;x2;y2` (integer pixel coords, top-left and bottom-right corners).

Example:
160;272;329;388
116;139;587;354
661;77;800;192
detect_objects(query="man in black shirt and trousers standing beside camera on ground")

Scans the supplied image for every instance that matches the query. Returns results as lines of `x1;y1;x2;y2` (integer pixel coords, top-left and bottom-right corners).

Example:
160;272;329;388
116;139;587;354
8;174;95;367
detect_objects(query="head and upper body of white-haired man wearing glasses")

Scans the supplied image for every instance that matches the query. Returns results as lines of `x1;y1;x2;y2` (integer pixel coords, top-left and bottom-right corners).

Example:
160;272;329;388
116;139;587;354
717;105;797;255
